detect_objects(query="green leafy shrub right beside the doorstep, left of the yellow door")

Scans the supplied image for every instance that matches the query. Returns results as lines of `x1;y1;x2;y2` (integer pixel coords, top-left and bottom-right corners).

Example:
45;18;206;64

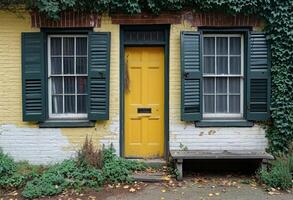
103;148;146;183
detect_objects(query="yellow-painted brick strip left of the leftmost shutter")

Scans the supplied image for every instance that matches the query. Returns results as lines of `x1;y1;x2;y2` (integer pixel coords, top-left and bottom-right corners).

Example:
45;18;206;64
0;11;39;125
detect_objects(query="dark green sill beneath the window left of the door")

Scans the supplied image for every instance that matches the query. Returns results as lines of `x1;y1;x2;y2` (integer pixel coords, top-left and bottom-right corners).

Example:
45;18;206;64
39;120;95;128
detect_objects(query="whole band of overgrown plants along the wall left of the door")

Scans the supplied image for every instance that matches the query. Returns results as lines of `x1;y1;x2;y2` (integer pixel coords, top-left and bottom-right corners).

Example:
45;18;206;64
0;138;146;199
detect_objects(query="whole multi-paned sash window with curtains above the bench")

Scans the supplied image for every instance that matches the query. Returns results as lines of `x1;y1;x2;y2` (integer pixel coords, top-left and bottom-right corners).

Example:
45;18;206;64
203;34;244;118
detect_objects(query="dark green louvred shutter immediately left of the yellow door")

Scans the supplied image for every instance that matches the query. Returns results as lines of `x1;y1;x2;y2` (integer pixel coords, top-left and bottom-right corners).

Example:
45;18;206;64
88;32;111;120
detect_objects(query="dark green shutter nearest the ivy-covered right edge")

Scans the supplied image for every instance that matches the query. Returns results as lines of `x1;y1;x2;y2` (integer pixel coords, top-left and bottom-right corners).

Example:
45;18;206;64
247;32;271;120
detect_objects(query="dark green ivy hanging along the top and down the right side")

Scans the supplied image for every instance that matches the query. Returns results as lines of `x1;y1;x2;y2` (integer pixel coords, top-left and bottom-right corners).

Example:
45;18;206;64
0;0;293;153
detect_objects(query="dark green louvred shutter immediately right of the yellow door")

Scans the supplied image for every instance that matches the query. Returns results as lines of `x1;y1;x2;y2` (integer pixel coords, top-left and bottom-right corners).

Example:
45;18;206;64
181;32;202;121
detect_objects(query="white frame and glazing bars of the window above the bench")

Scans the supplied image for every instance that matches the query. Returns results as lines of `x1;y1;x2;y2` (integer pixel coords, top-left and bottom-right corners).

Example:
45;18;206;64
202;34;244;119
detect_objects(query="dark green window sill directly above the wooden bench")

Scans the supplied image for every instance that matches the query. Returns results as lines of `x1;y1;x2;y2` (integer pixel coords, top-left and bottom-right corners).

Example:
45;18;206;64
195;120;253;127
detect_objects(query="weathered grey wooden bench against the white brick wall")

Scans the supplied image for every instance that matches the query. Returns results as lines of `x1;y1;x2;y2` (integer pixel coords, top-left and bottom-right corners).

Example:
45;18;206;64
170;150;274;180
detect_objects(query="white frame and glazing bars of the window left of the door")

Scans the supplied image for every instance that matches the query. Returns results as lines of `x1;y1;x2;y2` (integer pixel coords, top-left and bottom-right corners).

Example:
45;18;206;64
47;34;88;119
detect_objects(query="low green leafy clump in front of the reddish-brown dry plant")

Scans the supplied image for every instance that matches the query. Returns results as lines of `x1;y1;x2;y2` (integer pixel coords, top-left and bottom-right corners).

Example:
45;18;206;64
22;160;104;199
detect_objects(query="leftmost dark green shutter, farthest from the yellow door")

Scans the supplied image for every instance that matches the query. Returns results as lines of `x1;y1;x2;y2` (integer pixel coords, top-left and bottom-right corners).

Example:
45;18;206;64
21;32;46;121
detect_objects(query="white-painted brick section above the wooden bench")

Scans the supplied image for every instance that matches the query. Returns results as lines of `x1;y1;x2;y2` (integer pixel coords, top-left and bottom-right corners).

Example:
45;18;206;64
170;124;267;151
